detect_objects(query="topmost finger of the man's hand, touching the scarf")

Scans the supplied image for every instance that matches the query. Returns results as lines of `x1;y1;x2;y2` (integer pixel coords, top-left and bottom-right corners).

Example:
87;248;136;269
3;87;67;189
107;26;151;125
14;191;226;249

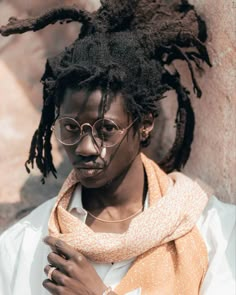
44;236;85;262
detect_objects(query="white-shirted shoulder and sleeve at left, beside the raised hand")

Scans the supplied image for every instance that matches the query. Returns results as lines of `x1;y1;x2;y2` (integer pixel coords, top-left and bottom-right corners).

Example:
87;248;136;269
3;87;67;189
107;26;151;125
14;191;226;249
0;198;55;294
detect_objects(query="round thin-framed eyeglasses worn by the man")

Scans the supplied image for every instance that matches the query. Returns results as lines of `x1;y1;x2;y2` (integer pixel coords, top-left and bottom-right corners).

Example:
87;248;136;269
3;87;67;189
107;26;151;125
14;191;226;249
52;117;137;147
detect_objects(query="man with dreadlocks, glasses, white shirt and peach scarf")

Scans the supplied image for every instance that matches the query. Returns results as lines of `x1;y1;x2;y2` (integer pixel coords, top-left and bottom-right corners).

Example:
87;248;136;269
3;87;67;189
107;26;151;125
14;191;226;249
0;1;235;295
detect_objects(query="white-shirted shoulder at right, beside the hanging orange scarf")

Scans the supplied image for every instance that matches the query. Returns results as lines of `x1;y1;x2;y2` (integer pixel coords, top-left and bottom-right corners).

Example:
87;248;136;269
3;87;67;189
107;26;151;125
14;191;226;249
197;196;236;295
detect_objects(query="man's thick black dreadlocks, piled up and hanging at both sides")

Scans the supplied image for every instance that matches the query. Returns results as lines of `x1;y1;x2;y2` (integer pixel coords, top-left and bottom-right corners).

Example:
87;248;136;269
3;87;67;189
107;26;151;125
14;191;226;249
0;0;211;181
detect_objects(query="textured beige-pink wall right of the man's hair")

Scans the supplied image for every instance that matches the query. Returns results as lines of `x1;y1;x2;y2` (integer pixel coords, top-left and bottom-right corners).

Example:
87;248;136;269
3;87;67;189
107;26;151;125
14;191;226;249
180;0;236;203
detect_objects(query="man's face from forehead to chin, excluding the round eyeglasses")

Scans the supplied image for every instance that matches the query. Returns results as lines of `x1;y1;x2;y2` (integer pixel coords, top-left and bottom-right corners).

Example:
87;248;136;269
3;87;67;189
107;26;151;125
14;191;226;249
60;88;140;188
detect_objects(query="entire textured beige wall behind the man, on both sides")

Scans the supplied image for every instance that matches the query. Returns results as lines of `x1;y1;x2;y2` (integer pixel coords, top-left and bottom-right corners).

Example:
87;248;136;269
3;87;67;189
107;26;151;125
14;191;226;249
0;0;236;230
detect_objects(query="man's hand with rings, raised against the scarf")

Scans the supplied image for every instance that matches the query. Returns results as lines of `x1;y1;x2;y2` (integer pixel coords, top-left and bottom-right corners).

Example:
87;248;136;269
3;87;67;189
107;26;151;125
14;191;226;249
43;236;108;295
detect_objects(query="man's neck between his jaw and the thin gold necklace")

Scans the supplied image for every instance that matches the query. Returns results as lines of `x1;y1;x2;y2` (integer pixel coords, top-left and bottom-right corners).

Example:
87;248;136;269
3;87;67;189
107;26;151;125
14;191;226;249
82;155;146;212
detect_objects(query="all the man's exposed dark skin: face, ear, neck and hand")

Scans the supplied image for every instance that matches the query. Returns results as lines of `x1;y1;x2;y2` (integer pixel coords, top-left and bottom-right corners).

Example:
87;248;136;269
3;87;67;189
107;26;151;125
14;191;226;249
43;89;153;295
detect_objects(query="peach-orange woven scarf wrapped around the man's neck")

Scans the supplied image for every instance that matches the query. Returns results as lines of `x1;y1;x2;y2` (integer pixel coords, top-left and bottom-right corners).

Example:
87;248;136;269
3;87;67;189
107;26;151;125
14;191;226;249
49;154;208;295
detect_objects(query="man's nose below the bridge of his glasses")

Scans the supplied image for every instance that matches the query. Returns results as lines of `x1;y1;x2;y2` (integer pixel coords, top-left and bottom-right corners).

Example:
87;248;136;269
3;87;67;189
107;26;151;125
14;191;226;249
75;133;100;157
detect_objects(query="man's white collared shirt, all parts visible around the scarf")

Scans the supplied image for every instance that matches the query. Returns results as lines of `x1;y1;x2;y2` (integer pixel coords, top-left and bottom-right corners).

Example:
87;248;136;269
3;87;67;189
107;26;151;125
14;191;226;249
0;186;236;295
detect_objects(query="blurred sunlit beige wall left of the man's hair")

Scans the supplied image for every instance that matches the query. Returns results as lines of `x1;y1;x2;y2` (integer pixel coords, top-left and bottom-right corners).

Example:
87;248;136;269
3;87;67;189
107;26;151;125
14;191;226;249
0;0;99;231
